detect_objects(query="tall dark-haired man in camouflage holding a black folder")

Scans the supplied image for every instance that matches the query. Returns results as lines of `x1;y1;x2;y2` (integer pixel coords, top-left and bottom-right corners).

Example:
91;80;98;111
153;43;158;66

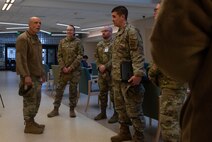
111;6;145;142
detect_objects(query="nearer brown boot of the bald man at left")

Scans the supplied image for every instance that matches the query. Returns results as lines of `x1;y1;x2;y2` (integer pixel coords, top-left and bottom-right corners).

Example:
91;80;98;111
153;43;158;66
24;120;44;134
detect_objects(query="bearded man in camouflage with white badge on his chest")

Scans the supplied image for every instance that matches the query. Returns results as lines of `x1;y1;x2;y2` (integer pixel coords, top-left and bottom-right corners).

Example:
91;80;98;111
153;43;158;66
94;27;118;123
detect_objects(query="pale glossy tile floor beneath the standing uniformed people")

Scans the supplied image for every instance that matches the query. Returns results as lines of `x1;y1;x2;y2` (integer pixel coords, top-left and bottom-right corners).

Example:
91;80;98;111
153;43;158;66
0;71;161;142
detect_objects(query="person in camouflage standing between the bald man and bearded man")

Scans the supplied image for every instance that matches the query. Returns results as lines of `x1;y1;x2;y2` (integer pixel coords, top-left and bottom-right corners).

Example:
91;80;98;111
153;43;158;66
47;25;84;117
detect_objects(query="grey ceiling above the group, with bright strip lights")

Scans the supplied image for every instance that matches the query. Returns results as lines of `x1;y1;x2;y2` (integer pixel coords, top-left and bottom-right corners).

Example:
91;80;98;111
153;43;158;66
0;0;157;32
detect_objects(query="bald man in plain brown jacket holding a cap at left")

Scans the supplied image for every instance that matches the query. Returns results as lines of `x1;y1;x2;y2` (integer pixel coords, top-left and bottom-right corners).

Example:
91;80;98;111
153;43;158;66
16;17;45;134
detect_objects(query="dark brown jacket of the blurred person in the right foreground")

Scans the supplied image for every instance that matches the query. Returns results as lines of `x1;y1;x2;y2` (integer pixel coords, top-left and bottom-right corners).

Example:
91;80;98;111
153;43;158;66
151;0;212;142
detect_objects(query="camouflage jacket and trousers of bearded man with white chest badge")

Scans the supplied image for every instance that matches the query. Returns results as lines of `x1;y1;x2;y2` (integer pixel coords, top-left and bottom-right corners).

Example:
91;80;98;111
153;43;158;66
94;38;114;116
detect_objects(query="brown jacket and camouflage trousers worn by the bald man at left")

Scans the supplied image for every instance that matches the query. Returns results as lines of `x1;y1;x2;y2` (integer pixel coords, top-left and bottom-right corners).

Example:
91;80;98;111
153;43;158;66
16;31;45;121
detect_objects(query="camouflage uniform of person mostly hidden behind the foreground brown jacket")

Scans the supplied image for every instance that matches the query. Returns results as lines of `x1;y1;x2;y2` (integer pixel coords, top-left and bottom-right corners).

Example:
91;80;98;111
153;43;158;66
148;64;186;142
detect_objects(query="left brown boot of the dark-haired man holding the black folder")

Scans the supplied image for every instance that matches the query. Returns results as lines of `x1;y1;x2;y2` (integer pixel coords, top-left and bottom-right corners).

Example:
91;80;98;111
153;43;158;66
111;124;132;142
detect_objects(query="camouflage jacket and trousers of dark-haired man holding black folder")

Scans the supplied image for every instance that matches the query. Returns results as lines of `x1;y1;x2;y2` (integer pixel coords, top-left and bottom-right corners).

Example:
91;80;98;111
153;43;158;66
112;23;145;139
